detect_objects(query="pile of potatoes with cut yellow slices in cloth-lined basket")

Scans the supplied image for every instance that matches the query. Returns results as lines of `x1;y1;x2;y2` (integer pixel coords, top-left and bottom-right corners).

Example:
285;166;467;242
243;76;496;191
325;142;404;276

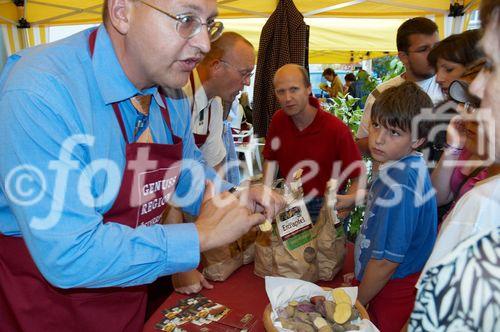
278;289;360;332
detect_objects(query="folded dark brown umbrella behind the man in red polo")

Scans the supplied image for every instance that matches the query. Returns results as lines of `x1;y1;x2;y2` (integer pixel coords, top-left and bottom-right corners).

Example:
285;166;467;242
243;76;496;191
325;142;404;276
253;0;309;137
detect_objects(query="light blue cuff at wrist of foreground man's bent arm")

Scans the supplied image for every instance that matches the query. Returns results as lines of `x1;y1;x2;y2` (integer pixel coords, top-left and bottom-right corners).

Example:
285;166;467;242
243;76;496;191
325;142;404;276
161;223;200;274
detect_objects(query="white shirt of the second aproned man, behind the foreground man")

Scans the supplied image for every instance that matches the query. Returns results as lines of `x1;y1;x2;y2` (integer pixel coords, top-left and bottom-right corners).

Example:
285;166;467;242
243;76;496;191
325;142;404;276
182;69;226;167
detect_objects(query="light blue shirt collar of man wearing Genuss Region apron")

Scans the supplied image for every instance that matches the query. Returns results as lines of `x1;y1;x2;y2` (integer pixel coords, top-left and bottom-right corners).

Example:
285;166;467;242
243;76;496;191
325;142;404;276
92;24;157;104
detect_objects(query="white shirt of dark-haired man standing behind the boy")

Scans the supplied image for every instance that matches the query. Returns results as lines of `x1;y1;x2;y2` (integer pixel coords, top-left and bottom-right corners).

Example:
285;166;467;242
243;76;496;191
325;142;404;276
356;75;444;139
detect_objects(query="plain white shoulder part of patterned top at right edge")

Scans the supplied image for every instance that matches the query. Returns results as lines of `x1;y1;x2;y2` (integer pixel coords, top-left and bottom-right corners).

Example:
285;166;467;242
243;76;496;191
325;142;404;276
417;175;500;287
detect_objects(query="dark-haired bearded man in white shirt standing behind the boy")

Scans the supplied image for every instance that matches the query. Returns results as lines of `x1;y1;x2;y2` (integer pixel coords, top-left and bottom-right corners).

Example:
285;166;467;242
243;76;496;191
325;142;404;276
356;17;443;155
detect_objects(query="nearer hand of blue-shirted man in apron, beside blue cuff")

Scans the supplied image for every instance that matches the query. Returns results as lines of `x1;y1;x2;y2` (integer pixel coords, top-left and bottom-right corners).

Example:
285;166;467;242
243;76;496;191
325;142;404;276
195;181;268;252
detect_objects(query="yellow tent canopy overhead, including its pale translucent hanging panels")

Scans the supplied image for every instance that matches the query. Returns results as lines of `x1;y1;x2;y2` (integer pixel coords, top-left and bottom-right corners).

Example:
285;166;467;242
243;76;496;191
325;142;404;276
0;0;479;63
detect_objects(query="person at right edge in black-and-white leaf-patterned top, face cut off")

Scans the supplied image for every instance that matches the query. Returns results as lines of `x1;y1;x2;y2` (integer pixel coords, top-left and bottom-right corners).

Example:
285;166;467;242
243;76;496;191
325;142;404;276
408;0;500;331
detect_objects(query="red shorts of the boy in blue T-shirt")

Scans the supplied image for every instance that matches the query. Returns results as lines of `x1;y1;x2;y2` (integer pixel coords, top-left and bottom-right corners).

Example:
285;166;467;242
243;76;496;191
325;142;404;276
353;272;420;332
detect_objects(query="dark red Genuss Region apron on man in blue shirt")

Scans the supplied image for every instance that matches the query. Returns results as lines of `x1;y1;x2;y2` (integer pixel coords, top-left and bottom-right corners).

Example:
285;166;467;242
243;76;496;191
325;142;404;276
0;31;182;332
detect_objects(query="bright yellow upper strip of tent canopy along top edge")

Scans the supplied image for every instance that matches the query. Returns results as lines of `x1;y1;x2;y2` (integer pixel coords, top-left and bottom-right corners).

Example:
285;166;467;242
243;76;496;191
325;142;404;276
0;0;479;24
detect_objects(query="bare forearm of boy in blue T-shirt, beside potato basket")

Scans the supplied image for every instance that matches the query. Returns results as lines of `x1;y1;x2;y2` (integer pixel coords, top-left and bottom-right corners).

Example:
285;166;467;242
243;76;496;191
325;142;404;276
358;259;399;305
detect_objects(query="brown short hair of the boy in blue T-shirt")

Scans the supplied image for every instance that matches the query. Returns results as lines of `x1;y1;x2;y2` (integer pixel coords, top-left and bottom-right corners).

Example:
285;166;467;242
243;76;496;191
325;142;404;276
371;81;433;138
